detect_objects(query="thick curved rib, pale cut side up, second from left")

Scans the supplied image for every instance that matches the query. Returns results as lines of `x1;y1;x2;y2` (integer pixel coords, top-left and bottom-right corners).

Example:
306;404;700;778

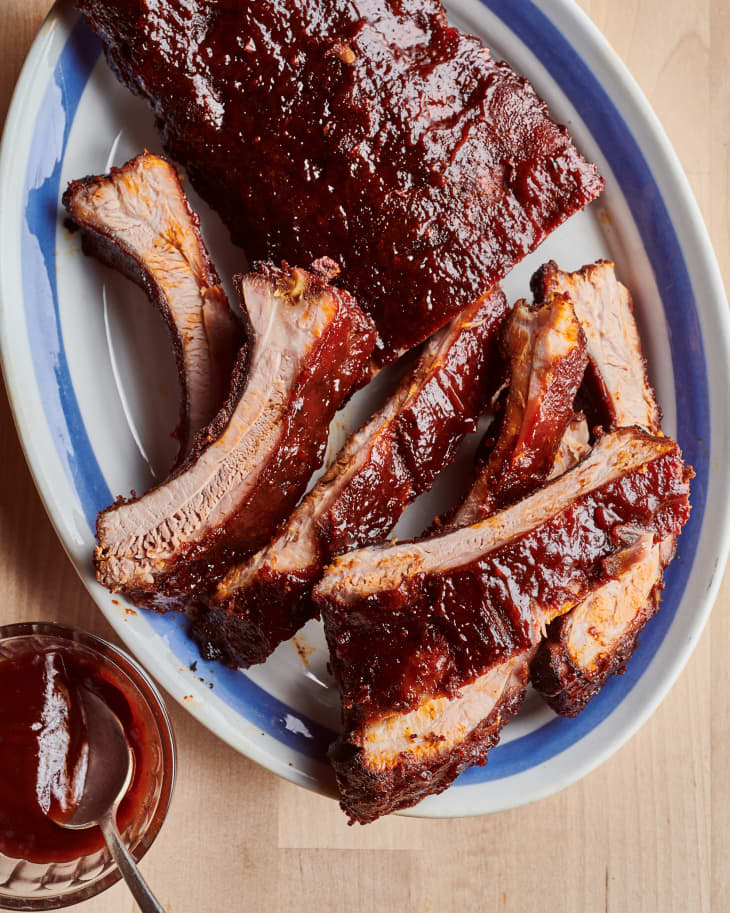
95;261;375;608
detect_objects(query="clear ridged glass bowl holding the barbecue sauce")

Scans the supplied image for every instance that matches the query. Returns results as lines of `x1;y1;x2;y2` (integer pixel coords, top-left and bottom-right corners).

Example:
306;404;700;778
0;622;176;910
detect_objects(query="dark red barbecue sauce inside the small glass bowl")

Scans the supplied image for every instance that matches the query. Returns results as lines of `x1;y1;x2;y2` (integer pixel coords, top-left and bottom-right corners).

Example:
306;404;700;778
0;646;154;863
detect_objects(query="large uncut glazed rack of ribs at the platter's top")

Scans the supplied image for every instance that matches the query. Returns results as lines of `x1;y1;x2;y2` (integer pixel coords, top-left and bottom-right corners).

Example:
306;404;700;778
78;0;603;361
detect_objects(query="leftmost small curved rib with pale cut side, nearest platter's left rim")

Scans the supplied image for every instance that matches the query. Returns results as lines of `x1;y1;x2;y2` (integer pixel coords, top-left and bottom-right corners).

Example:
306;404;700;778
63;152;243;462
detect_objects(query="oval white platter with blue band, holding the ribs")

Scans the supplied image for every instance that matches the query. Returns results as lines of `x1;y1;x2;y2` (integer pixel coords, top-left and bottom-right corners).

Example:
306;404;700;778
0;0;730;816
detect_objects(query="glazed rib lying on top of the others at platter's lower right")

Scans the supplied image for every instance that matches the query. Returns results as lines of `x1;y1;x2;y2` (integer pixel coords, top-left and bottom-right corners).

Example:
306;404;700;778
314;428;689;720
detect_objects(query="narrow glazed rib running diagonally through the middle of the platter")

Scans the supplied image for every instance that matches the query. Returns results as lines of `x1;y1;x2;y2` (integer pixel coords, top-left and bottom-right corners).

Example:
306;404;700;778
194;288;507;666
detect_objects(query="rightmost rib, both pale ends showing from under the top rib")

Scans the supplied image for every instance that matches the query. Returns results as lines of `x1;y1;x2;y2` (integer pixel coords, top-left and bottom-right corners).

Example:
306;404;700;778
531;261;676;716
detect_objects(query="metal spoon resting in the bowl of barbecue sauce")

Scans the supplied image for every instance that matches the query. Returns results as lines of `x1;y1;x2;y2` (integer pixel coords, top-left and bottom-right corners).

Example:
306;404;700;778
53;687;165;913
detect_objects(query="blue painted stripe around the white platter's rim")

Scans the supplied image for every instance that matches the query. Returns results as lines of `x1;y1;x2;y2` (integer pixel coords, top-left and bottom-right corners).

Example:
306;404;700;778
22;0;710;785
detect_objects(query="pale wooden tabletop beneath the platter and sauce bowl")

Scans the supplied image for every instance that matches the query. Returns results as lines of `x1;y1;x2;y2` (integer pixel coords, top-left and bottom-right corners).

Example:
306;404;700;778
0;0;730;913
